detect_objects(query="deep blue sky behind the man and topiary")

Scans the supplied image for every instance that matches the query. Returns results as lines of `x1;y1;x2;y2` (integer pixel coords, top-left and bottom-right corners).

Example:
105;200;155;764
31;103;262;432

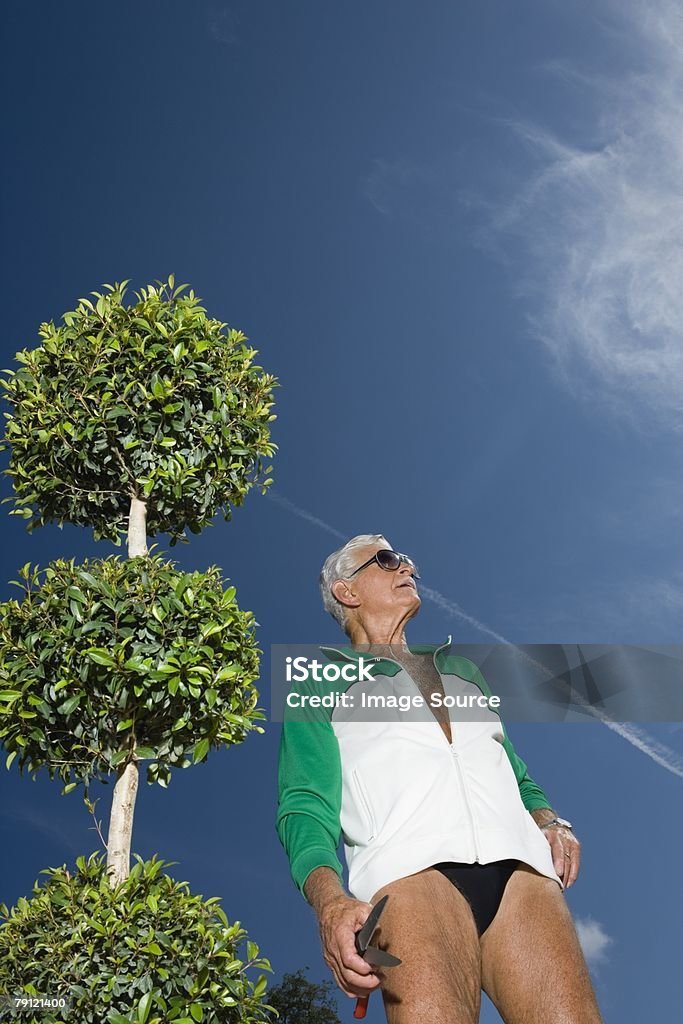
0;0;683;1024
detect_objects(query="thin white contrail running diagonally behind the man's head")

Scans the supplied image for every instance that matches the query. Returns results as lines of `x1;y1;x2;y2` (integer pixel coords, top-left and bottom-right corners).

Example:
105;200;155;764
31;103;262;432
267;492;683;778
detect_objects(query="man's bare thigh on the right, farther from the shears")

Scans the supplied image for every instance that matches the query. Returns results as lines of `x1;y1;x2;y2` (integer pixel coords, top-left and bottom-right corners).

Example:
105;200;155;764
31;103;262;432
480;864;602;1024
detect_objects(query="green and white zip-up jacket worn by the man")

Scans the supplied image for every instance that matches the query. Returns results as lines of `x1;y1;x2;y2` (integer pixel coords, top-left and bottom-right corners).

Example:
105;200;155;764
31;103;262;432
276;637;562;901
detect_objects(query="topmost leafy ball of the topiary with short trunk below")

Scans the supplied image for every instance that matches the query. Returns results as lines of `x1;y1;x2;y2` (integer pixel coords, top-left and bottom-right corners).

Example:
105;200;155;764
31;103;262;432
0;276;275;555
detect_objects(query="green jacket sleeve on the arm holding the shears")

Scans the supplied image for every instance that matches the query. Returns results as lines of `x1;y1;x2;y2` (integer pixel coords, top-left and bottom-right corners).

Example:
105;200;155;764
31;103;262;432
275;684;342;897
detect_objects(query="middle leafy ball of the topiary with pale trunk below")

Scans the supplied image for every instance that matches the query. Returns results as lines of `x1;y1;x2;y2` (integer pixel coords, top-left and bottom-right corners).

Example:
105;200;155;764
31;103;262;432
0;555;263;883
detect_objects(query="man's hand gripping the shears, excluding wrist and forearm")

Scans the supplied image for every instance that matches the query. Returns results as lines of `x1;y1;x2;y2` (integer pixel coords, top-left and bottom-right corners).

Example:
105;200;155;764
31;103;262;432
319;895;380;995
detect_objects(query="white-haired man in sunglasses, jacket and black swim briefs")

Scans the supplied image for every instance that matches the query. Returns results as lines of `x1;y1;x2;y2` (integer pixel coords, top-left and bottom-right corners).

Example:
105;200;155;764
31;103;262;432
276;534;601;1024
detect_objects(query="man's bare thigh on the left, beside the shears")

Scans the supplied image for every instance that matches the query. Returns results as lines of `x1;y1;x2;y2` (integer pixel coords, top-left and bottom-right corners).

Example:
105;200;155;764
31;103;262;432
371;867;481;1024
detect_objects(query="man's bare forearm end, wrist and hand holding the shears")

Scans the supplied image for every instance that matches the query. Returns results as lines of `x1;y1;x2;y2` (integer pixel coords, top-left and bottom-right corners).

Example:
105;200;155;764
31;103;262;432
304;867;380;995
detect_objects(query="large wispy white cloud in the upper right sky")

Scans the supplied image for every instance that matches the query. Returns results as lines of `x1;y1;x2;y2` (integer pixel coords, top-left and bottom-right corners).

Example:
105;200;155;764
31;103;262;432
488;0;683;432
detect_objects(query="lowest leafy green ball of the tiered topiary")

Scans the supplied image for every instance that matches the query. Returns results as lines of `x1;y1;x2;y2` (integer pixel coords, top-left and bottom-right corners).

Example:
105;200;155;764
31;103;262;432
0;854;274;1024
